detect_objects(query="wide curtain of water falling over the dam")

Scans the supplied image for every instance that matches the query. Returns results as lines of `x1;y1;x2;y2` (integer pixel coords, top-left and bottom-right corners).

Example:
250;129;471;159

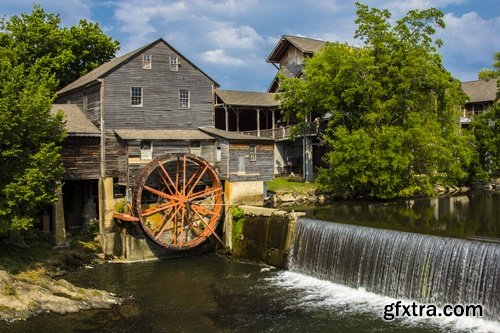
288;218;500;320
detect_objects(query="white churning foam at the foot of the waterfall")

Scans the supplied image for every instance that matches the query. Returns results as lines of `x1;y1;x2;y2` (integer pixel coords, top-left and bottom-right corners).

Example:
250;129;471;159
270;271;500;333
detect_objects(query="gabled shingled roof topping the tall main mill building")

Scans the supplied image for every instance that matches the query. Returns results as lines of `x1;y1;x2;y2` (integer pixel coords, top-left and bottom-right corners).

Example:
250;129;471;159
57;38;219;94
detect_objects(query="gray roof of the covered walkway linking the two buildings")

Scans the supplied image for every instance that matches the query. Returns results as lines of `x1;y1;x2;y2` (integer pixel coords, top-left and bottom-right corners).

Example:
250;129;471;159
215;89;280;107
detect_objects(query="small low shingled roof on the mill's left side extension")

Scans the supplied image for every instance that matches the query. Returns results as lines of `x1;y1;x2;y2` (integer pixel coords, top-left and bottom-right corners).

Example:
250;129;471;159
50;104;101;136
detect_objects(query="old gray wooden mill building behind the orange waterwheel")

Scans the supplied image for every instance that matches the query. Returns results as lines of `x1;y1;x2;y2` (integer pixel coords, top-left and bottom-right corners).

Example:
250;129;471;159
53;39;274;257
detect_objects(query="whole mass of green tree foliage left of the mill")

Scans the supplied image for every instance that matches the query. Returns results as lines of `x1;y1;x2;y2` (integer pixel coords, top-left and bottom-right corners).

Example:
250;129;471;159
0;5;118;232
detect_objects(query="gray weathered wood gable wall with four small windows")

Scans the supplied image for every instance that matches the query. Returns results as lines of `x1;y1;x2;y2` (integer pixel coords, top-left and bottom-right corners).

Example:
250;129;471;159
103;43;213;129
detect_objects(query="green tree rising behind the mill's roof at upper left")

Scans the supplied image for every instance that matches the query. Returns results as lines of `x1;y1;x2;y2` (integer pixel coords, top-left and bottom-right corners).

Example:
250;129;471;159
0;5;119;89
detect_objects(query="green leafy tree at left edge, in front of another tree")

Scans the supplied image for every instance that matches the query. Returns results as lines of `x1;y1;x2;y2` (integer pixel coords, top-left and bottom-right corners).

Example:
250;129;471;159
0;47;65;232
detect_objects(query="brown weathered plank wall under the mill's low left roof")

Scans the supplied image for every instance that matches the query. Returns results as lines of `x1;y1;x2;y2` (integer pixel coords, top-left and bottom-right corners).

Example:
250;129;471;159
61;136;100;180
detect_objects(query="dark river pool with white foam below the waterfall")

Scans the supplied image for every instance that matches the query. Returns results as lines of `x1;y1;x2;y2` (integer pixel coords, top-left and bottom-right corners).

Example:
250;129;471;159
0;255;494;333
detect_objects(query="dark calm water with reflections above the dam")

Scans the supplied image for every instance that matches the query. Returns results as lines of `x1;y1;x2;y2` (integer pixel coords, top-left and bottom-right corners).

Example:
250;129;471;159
285;192;500;239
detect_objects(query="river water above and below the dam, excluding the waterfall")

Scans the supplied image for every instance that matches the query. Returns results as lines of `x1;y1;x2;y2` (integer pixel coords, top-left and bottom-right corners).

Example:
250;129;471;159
0;194;500;333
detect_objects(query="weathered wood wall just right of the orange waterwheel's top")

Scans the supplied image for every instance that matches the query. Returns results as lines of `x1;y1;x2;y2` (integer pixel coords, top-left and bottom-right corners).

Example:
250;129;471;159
229;143;274;181
